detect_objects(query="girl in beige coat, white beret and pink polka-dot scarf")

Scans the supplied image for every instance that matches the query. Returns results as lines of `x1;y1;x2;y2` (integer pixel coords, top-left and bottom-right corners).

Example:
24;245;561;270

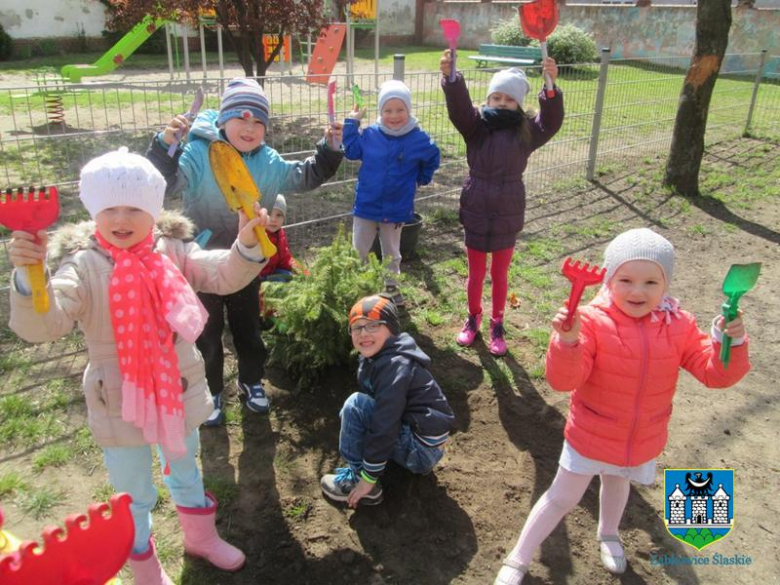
9;148;268;585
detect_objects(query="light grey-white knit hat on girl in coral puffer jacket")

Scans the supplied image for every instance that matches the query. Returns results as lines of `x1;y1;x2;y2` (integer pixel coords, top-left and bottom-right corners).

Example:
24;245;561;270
604;228;674;288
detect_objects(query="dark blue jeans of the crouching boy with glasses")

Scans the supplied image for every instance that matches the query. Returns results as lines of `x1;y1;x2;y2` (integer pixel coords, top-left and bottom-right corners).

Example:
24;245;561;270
339;392;444;473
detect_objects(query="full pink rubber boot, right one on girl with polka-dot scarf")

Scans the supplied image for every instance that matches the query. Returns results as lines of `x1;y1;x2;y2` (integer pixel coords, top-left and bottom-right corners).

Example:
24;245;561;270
176;492;246;571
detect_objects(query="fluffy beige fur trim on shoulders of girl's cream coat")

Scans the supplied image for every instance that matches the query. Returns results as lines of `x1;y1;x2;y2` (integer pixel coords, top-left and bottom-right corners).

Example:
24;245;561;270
47;210;195;263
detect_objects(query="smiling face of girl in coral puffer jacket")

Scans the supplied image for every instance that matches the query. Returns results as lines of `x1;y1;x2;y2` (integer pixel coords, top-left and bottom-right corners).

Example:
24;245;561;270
608;260;666;318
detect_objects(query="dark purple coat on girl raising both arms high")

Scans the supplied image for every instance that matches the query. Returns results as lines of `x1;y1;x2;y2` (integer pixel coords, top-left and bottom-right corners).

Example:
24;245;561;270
441;73;563;252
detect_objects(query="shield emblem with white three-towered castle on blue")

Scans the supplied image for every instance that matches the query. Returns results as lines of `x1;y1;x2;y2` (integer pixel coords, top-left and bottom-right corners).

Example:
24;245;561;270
664;469;734;550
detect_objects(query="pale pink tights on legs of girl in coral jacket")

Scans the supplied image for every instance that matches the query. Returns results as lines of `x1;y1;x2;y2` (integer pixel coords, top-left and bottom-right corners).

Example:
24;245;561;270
509;467;630;567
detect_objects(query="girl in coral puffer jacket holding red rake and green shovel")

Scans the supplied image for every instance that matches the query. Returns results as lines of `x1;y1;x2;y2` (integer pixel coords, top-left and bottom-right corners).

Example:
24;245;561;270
495;228;750;585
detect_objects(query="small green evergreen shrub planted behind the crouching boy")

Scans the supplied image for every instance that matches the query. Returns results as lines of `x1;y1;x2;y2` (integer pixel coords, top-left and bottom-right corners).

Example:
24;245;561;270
263;226;385;388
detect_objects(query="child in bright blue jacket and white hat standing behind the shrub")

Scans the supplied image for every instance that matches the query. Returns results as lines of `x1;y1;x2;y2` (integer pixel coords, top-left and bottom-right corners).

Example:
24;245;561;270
344;79;439;306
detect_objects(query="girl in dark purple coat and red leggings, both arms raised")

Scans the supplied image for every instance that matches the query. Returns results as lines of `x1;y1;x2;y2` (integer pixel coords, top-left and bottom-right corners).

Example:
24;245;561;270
440;49;563;356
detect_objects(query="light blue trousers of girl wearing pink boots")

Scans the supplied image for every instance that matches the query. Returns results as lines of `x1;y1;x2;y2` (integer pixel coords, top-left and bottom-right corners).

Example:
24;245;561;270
103;430;207;554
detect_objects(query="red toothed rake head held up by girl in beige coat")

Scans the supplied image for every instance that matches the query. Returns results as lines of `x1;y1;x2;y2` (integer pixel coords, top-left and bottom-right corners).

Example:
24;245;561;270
0;187;60;233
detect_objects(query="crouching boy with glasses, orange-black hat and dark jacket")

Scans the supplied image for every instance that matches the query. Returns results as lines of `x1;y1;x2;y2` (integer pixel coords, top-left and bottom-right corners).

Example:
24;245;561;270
320;293;455;508
